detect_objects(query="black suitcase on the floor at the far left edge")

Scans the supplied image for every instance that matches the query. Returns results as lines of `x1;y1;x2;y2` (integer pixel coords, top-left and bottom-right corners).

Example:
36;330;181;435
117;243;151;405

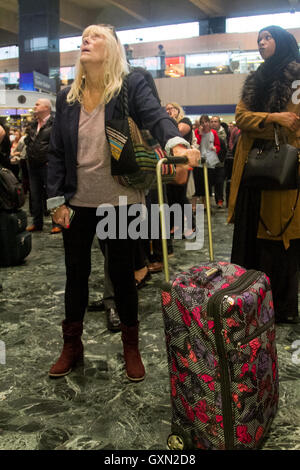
0;209;32;266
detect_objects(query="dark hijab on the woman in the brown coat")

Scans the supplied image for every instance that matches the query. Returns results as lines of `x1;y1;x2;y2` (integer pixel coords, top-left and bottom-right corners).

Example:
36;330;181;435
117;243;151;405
242;25;300;112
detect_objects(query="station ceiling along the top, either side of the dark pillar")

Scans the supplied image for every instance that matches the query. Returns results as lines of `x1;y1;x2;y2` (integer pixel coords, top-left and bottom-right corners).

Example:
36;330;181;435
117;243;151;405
0;0;300;46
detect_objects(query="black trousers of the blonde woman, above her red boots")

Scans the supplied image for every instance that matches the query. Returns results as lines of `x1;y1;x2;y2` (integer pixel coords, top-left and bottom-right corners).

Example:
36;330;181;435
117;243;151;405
63;207;139;326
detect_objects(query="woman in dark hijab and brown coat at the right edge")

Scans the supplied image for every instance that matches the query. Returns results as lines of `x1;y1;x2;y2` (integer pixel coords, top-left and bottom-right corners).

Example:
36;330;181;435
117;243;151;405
228;26;300;323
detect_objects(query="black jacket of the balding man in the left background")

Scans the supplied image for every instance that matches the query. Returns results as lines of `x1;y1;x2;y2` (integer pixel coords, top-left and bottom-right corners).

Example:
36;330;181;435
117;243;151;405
25;115;54;168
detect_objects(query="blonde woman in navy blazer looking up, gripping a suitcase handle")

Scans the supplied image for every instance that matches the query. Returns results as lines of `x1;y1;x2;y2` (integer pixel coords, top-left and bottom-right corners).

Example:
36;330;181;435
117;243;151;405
48;25;200;381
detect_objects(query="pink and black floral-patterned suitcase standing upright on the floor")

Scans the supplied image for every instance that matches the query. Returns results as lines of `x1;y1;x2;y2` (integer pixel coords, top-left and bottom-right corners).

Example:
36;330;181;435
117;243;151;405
162;262;278;449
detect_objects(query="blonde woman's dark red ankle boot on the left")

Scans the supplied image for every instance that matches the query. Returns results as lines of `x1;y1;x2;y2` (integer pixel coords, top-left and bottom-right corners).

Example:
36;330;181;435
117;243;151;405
49;320;83;377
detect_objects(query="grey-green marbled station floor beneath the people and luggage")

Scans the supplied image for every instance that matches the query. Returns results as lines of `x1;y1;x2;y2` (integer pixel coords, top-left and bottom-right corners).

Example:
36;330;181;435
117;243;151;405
0;203;300;450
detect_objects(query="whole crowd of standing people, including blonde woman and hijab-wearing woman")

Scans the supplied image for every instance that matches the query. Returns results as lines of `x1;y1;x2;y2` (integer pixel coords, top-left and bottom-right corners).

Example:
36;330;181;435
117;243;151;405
0;25;300;381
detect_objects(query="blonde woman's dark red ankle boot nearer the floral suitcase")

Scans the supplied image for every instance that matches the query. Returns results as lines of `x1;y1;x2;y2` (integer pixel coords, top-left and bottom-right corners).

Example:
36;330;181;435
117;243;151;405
121;323;145;382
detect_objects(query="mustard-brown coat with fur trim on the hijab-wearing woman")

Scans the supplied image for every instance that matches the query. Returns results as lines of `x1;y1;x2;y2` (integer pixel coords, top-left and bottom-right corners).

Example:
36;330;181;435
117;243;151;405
228;62;300;249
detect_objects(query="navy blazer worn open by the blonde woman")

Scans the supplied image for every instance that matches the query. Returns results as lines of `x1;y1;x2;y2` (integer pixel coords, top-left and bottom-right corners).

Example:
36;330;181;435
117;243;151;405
47;72;181;202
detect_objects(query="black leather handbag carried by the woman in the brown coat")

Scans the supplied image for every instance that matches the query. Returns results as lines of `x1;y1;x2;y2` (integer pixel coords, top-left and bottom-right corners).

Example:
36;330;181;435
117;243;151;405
242;126;300;190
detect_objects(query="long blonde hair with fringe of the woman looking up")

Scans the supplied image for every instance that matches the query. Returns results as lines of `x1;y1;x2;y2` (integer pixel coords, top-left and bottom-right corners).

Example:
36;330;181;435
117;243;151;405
67;24;128;104
